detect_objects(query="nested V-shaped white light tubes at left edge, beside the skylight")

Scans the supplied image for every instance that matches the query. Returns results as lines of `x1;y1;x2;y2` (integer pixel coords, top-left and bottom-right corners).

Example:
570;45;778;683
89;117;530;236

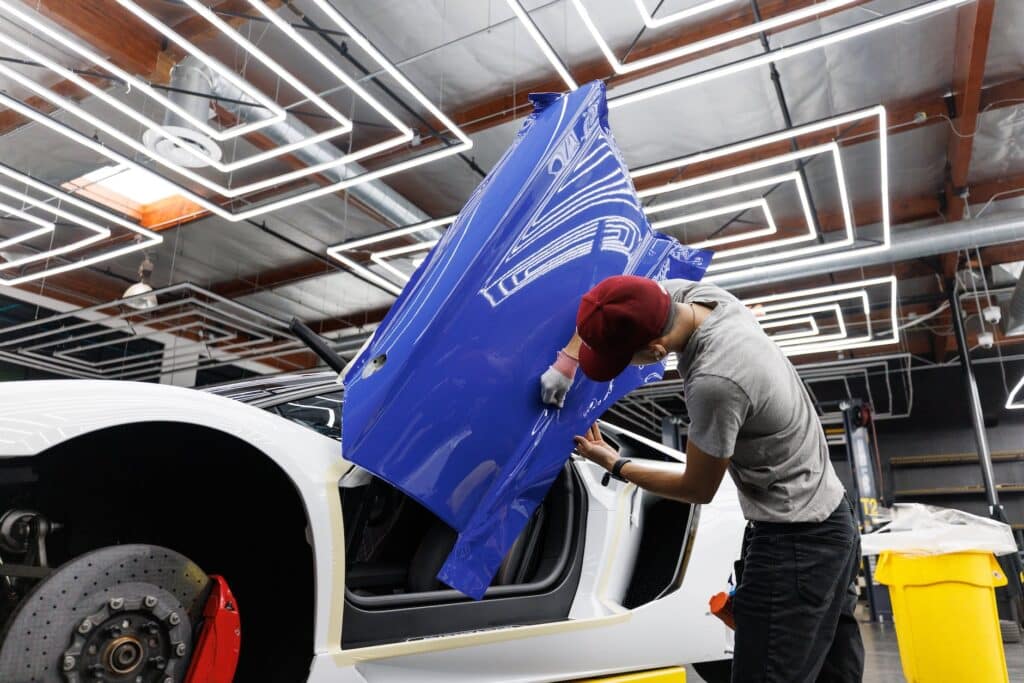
0;164;164;286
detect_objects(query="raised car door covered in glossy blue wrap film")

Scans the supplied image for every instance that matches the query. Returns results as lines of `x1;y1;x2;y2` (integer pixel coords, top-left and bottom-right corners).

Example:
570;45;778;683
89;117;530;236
344;83;711;598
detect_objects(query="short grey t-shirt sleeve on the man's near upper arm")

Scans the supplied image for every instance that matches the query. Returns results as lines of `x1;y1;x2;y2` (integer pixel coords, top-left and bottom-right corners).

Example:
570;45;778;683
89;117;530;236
686;375;751;458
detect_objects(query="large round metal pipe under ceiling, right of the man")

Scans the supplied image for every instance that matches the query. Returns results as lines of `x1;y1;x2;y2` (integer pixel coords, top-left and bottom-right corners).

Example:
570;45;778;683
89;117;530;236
707;211;1024;289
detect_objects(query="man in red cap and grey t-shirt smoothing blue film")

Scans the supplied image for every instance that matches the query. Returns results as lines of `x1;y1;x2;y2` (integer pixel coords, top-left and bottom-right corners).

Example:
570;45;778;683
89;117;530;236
542;275;863;683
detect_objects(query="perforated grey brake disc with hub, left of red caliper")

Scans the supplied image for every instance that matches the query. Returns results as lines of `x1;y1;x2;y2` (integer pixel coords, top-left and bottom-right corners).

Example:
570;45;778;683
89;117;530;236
0;545;211;683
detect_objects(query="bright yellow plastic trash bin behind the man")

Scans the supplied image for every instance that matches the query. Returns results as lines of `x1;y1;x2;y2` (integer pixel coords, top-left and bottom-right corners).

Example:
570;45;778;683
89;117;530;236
874;553;1009;683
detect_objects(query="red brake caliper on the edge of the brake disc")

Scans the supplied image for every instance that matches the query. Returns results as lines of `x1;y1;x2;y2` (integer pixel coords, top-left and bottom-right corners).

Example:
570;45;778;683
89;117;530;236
185;577;242;683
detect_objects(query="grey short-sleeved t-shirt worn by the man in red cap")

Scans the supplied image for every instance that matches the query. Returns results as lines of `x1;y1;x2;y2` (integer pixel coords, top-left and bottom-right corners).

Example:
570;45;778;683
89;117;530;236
663;280;845;522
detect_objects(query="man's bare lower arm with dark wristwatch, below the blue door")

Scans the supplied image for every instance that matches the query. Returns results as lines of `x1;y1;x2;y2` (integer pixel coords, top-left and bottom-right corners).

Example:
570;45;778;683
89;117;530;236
575;424;729;505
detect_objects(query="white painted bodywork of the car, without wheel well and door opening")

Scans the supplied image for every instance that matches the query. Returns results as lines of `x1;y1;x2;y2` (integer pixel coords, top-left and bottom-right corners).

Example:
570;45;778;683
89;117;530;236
0;380;744;683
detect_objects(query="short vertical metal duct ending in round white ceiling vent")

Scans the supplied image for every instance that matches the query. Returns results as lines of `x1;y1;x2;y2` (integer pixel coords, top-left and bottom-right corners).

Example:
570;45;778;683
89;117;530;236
142;60;221;168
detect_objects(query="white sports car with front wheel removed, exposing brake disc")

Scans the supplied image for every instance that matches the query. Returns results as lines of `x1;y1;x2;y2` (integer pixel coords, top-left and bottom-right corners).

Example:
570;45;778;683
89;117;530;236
0;373;743;683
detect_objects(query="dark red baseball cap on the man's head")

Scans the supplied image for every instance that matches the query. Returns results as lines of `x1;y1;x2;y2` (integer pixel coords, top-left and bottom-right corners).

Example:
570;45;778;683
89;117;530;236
577;275;672;382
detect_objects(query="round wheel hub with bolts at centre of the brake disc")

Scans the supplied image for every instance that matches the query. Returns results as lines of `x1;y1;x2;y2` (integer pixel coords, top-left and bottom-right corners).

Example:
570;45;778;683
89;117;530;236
62;595;189;683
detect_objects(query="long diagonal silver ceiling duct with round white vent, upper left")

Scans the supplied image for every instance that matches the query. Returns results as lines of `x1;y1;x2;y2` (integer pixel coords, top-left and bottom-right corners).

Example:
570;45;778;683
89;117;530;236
145;56;432;229
